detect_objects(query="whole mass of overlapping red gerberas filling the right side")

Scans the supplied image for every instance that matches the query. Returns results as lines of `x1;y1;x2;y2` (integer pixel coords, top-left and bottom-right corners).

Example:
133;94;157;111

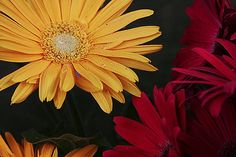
103;0;236;157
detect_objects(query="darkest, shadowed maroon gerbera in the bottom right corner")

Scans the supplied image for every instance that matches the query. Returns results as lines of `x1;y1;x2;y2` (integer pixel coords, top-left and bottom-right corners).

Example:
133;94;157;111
179;100;236;157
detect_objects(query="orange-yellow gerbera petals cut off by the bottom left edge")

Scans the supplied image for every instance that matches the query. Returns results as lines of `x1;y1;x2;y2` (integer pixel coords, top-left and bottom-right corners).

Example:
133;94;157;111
0;132;97;157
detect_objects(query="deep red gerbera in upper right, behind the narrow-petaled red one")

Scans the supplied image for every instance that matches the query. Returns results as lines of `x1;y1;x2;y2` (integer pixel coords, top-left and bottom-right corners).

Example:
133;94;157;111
174;0;231;75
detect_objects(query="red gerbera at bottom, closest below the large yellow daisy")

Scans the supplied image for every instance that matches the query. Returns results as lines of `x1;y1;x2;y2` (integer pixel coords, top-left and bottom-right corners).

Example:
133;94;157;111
103;84;185;157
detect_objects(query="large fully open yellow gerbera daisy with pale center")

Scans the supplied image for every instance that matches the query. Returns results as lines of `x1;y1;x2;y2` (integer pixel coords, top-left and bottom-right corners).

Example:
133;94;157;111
0;0;162;113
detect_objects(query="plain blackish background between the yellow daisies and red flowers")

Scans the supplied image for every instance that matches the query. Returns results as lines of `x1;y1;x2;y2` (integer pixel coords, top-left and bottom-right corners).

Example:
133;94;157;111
0;0;192;155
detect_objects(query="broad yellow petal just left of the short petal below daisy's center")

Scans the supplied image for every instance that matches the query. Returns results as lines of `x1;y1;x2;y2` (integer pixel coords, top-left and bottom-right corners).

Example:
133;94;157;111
39;63;61;102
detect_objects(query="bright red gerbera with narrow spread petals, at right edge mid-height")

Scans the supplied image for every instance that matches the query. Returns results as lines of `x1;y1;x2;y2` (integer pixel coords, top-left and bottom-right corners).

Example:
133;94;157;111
173;39;236;116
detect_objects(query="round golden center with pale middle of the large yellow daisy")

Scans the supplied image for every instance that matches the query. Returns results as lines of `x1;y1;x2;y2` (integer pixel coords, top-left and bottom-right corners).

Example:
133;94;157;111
41;22;91;63
